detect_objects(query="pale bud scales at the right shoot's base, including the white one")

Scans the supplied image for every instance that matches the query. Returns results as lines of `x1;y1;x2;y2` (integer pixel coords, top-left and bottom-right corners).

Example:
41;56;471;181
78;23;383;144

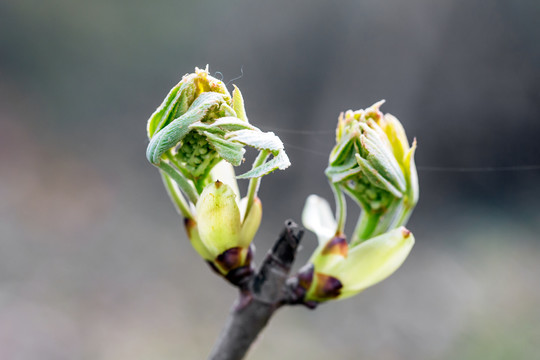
298;195;414;303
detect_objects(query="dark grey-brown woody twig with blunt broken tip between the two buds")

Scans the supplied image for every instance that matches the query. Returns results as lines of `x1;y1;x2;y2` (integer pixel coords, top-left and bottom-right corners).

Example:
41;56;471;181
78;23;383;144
208;220;303;360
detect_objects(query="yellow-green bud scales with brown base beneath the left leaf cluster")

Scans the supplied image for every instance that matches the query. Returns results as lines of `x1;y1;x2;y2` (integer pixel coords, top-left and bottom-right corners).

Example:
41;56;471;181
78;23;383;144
193;181;262;276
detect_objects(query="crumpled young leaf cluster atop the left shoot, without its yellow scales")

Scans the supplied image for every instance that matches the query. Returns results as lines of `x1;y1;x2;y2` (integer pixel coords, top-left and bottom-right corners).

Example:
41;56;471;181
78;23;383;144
146;67;290;188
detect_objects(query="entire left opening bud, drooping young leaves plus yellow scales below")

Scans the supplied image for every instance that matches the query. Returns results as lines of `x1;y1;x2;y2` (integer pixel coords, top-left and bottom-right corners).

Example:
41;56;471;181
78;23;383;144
146;67;290;277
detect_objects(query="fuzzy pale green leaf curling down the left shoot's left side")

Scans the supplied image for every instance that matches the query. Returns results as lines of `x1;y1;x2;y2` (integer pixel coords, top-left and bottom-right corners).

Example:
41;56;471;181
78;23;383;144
146;92;223;164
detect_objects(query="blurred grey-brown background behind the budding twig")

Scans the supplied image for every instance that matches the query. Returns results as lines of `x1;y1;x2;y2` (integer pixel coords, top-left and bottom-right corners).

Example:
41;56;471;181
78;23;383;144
0;0;540;360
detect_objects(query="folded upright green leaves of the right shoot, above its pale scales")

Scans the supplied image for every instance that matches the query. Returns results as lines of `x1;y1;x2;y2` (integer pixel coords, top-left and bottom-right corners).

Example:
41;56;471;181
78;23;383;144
326;101;418;243
